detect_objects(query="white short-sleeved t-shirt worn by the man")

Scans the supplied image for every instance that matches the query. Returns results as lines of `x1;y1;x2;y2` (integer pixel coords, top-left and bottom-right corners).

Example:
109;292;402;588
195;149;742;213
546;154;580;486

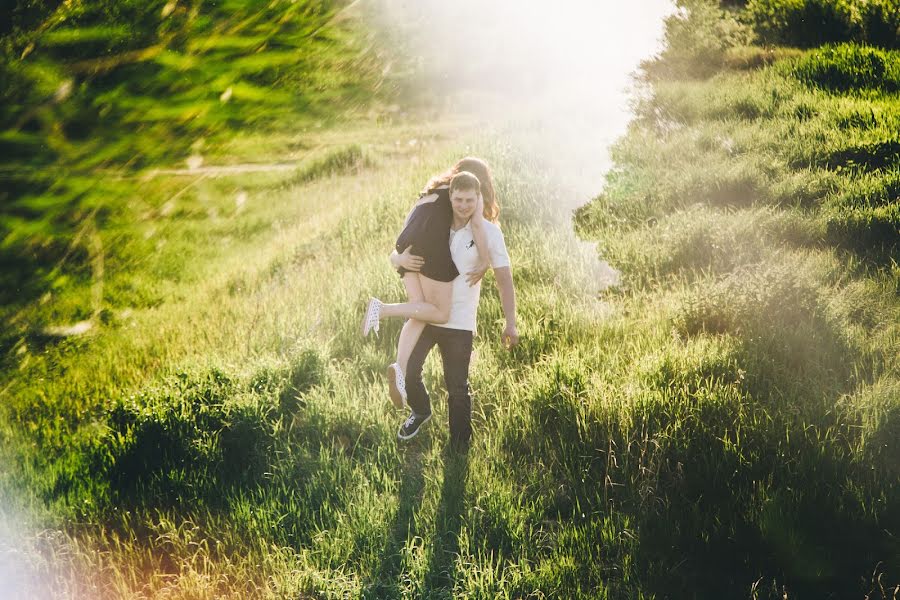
436;221;510;332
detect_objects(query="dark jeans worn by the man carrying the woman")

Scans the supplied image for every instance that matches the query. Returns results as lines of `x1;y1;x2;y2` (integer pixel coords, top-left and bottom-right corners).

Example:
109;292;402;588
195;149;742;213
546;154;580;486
406;325;472;442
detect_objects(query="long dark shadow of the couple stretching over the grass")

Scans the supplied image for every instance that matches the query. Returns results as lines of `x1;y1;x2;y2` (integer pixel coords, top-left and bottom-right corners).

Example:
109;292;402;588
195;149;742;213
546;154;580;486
363;443;469;599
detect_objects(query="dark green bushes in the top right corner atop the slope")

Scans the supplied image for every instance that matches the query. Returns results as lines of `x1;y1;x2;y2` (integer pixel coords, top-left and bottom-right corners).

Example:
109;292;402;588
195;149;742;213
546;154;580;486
747;0;900;48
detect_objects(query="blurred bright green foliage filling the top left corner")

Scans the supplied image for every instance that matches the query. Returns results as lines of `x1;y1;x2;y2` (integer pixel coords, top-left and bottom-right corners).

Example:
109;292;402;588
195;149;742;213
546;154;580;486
0;0;390;324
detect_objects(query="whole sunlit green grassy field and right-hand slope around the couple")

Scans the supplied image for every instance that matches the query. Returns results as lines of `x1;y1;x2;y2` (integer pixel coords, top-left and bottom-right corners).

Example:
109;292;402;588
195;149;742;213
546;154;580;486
0;0;900;600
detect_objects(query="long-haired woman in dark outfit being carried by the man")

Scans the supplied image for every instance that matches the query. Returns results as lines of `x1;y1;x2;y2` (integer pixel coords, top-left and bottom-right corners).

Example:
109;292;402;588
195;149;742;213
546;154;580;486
363;157;500;408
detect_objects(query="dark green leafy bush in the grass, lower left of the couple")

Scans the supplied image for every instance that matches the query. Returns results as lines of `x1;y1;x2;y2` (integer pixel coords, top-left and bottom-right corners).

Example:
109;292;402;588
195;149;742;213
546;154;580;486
98;369;276;503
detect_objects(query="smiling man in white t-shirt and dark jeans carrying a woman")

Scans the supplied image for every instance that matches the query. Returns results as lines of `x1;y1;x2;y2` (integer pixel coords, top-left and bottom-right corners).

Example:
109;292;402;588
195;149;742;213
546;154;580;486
397;171;519;447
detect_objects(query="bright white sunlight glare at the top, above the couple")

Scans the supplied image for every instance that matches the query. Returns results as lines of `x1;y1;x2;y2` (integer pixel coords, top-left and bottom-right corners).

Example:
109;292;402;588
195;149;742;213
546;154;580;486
370;0;674;208
